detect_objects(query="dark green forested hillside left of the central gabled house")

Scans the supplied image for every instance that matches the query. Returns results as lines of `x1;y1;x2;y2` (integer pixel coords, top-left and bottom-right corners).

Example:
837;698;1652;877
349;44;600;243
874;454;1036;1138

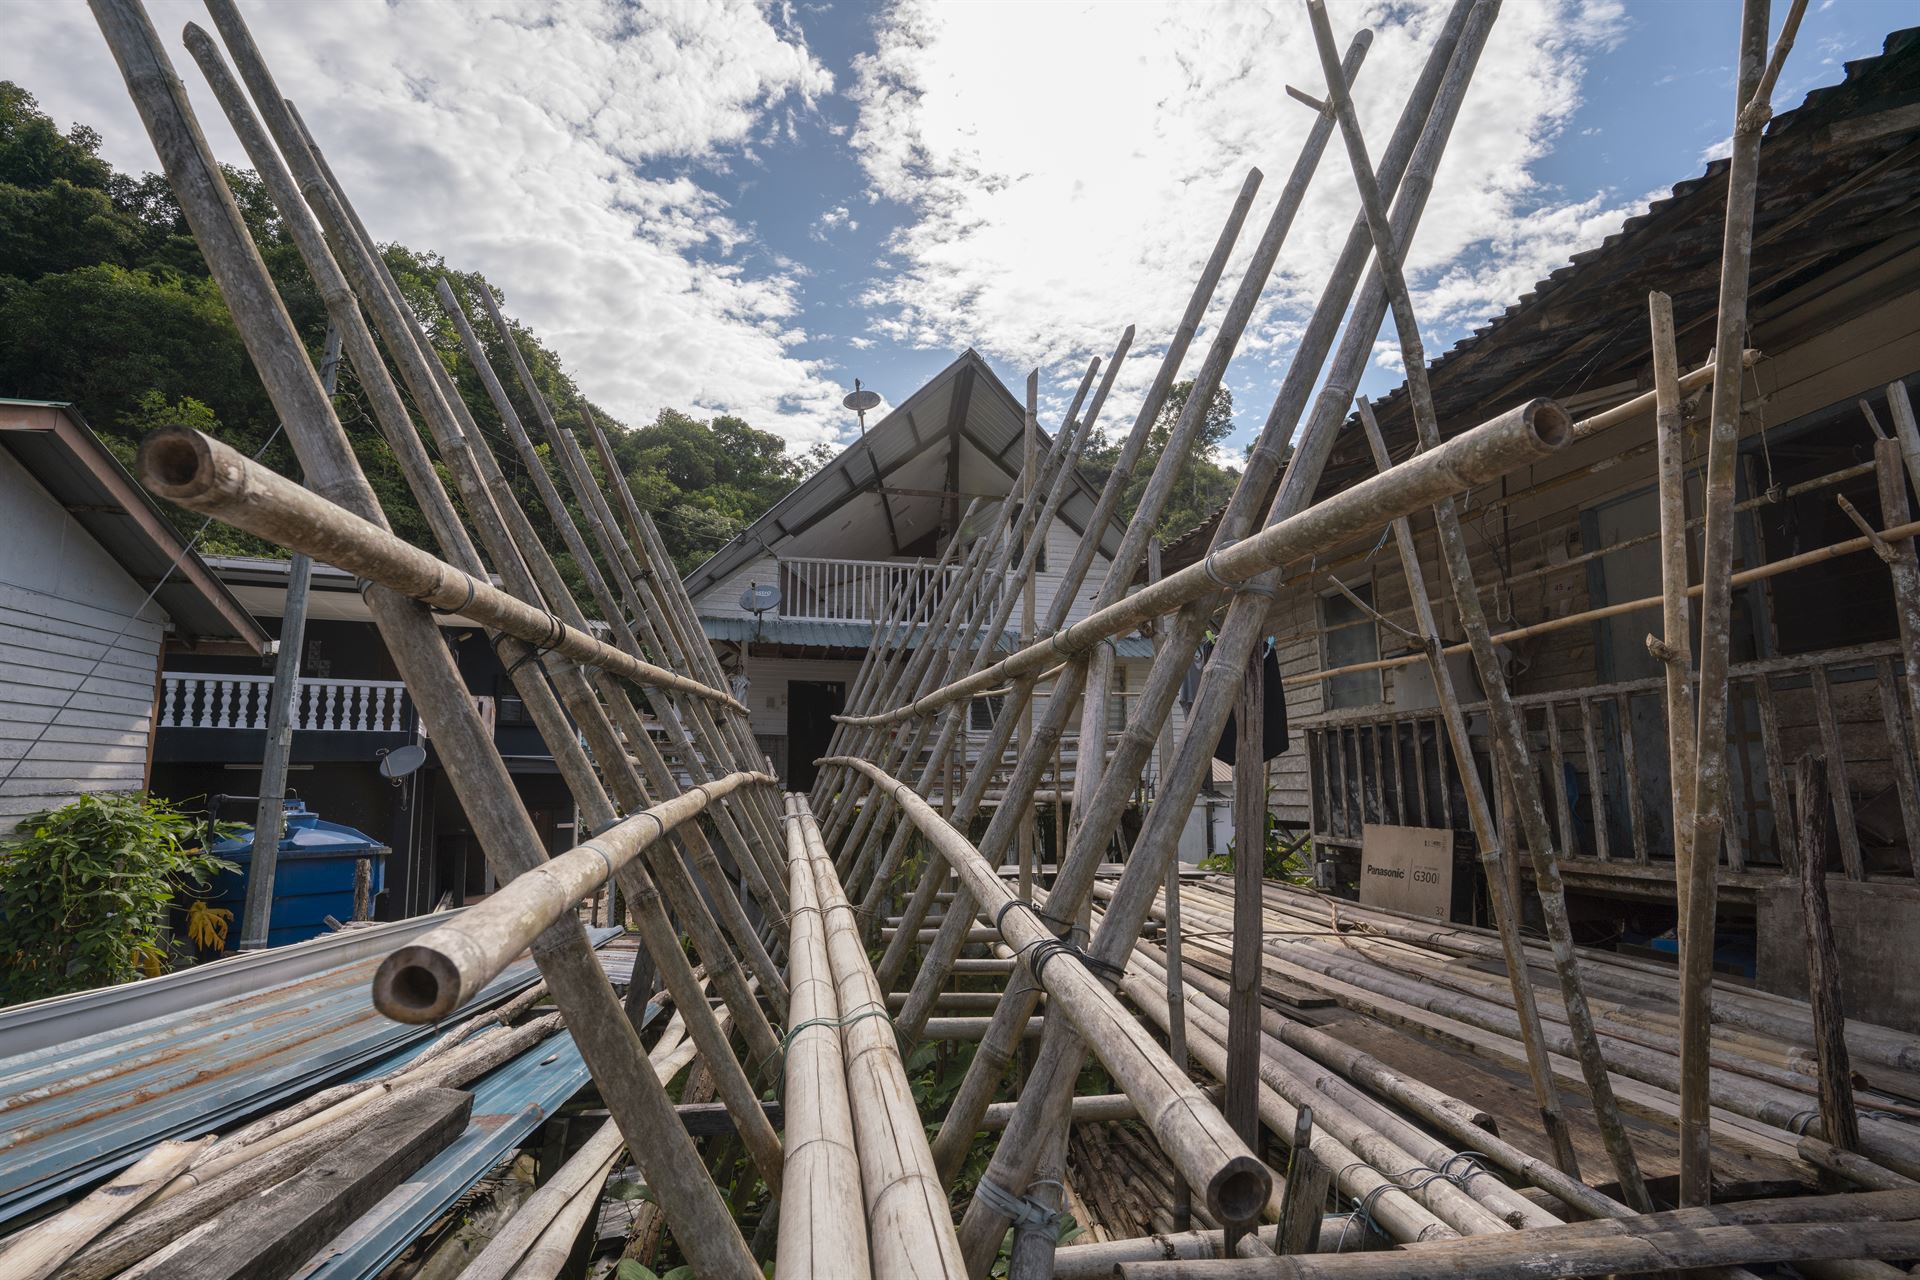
0;81;812;579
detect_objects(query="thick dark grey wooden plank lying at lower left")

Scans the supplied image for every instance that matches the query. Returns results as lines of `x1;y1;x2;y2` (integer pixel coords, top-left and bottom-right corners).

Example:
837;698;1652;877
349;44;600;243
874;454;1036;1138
144;1088;472;1280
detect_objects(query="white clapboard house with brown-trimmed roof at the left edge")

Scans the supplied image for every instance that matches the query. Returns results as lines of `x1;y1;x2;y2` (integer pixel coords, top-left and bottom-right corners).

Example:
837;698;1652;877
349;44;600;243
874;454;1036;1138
0;399;271;831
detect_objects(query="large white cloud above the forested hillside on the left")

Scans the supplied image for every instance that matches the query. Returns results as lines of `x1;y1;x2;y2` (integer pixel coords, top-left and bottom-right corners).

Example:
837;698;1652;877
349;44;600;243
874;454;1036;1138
0;0;843;445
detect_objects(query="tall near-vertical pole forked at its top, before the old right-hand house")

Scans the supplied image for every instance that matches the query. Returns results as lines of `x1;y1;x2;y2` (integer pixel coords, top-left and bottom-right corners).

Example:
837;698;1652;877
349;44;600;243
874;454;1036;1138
1674;0;1807;1205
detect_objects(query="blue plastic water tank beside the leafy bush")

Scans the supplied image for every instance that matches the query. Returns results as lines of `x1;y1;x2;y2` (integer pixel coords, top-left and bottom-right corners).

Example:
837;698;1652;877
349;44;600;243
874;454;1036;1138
209;800;394;950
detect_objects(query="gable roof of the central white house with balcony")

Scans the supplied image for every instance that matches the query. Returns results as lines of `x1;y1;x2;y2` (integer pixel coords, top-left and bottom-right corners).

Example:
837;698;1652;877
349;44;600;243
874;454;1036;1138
685;347;1123;599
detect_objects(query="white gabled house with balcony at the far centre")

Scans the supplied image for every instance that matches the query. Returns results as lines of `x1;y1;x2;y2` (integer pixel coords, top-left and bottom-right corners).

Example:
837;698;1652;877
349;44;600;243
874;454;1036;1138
685;349;1227;856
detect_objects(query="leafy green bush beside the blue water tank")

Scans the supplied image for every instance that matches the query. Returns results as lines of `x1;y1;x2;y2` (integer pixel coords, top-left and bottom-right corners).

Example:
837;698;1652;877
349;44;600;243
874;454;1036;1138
0;793;236;1004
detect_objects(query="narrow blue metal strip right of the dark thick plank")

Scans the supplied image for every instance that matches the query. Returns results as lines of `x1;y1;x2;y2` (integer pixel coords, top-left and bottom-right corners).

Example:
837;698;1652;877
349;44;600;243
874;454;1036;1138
294;1031;588;1280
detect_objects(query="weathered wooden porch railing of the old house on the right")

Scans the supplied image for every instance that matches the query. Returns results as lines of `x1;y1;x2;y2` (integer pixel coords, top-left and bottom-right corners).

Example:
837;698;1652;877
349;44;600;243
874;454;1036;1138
1300;641;1920;879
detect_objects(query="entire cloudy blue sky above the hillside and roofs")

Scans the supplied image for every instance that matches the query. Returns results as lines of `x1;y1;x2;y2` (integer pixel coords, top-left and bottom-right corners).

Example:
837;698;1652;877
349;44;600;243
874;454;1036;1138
0;0;1920;460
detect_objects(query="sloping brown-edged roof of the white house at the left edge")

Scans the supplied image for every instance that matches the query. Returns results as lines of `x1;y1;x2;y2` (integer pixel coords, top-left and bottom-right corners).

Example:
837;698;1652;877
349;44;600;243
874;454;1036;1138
0;399;271;652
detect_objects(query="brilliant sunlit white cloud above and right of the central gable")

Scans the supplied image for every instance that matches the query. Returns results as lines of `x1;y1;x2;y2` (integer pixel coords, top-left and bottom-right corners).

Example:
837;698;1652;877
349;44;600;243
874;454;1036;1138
849;0;1640;422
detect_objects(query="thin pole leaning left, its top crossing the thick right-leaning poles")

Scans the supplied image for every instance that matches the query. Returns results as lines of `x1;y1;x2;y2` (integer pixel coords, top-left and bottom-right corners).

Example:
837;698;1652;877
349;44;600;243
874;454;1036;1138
1308;0;1651;1209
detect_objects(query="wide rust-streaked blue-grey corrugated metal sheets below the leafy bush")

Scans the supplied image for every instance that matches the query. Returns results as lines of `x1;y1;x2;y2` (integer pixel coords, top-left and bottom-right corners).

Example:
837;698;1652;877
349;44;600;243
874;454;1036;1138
0;921;618;1222
